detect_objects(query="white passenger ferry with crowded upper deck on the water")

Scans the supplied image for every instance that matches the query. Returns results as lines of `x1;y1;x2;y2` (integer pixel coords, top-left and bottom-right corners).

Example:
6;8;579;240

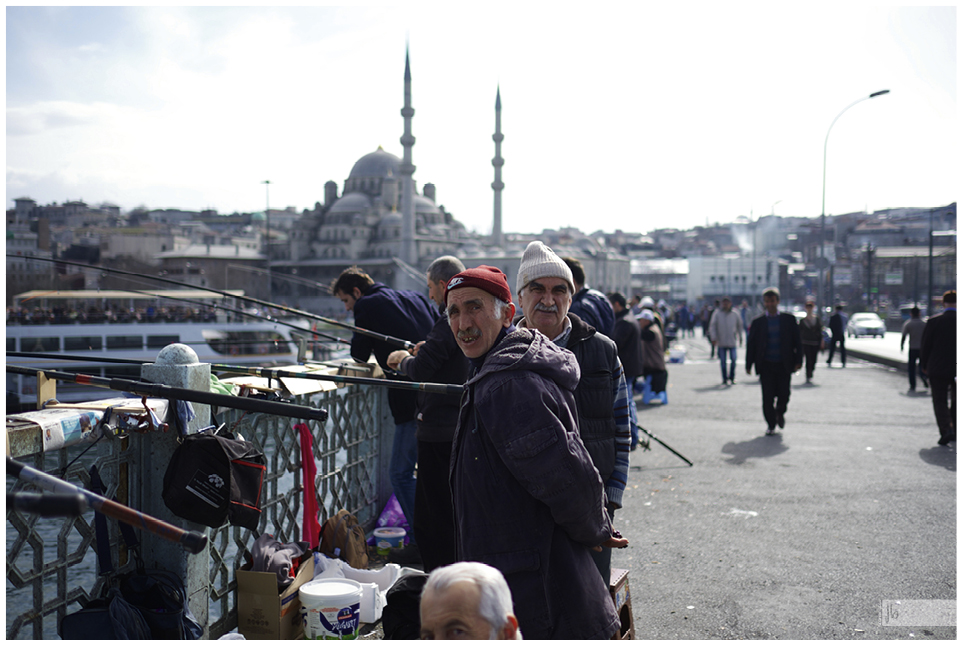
6;289;346;413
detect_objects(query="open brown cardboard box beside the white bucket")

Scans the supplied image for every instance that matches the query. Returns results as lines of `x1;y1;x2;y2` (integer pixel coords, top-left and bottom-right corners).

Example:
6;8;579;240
237;556;314;641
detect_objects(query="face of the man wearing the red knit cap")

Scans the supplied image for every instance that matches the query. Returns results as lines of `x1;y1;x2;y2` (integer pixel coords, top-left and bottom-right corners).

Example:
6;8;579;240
446;287;515;359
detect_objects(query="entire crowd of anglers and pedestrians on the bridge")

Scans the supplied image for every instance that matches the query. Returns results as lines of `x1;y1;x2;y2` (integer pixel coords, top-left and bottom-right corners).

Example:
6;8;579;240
331;249;955;639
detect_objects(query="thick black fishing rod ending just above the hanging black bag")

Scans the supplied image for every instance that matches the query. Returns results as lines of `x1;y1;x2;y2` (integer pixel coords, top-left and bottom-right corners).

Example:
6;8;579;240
7;360;328;422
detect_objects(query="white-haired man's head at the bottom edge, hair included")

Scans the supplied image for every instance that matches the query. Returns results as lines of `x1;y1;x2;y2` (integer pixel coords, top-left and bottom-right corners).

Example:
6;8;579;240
421;562;522;641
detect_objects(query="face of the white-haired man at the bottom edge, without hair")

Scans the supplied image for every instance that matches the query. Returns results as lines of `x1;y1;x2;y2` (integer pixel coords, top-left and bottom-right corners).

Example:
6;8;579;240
421;581;504;641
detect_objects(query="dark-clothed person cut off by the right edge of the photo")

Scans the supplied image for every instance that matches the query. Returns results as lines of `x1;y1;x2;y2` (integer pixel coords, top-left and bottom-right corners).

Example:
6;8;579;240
920;291;956;445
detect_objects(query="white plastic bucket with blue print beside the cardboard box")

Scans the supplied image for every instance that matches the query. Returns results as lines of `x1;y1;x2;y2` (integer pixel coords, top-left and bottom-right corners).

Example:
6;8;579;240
299;578;361;640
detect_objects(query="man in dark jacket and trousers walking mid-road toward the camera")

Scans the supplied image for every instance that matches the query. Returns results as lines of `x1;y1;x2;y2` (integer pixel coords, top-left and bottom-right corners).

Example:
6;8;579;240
746;287;802;436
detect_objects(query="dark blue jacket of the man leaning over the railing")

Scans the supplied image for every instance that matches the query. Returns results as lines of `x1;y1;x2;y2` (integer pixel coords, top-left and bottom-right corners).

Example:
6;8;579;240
351;282;438;424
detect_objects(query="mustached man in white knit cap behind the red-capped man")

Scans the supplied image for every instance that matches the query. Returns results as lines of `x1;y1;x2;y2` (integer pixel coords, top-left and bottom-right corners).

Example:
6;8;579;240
515;241;632;584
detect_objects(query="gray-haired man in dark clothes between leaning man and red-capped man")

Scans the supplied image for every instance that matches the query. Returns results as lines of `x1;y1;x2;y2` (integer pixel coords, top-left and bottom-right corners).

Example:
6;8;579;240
388;255;468;573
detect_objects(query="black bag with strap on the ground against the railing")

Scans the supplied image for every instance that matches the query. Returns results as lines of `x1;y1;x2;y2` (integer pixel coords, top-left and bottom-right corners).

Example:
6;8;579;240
58;466;203;641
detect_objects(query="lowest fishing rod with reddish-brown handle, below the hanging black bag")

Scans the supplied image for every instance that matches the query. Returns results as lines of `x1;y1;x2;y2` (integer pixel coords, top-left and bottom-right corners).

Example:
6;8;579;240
7;456;207;554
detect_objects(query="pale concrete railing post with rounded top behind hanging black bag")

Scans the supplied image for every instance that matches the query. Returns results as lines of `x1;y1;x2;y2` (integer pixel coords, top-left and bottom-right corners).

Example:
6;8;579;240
140;343;211;639
